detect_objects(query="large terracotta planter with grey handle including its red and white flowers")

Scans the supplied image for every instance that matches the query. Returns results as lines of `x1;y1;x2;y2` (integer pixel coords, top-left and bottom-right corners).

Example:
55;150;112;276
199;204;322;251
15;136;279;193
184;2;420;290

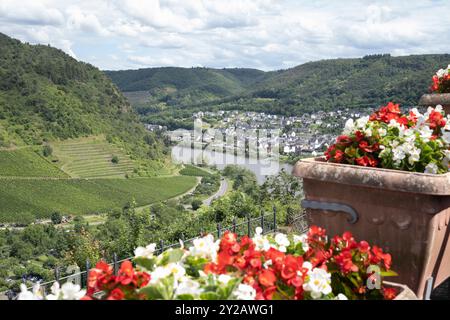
294;103;450;298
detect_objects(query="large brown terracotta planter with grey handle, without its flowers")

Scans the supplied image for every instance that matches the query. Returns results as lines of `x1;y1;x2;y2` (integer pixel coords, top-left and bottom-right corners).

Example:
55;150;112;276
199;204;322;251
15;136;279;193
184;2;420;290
294;158;450;298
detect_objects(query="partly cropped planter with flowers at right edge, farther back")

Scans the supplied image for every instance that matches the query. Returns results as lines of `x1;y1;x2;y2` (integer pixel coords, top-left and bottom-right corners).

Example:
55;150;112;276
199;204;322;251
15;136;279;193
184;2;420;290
419;64;450;113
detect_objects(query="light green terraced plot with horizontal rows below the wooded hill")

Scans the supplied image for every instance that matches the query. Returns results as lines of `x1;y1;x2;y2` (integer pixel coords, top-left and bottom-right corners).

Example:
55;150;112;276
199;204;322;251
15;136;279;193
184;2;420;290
52;137;135;178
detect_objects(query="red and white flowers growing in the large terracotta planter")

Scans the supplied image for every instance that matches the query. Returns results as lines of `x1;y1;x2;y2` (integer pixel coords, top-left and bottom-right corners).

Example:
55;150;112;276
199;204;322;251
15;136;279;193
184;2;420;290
325;102;450;174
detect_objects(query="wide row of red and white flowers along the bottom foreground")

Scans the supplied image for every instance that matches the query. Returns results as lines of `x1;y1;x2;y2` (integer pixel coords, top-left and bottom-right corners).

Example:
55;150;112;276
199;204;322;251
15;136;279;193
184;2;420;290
15;227;397;300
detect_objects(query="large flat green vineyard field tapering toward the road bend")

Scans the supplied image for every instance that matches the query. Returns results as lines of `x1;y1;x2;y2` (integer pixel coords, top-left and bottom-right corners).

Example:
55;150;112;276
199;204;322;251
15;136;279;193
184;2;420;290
0;176;196;222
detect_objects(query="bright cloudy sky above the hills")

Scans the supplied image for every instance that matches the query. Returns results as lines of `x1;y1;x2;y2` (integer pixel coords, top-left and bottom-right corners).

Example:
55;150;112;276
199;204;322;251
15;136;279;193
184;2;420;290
0;0;450;70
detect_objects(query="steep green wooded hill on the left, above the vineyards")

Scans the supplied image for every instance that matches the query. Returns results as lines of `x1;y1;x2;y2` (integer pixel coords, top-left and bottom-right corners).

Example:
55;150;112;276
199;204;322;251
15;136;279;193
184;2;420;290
0;33;168;158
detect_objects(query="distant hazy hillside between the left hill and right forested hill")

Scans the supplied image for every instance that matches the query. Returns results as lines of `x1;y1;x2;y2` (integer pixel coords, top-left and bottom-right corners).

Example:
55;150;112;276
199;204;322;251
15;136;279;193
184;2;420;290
105;67;266;113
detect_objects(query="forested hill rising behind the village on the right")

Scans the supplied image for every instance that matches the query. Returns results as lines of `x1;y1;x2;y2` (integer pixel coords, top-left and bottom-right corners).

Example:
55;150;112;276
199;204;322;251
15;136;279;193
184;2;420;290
249;54;450;113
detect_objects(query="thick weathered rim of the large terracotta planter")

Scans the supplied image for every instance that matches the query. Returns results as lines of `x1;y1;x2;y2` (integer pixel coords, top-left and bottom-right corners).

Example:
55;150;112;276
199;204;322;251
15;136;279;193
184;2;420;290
293;157;450;196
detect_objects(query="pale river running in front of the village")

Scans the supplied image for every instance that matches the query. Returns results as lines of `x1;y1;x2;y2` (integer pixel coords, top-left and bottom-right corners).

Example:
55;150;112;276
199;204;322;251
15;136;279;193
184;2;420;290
172;146;293;184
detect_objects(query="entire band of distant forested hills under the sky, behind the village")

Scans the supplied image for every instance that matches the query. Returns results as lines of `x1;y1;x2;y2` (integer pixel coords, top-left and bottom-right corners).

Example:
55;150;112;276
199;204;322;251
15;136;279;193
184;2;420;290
107;54;450;120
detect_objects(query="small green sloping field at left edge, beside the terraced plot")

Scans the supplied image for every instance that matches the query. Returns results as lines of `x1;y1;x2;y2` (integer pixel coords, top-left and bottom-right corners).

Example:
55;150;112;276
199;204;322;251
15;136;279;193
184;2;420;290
0;148;68;178
